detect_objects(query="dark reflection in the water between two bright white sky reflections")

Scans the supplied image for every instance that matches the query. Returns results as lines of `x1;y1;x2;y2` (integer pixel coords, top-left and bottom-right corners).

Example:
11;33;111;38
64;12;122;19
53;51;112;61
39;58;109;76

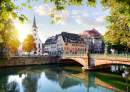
22;73;41;92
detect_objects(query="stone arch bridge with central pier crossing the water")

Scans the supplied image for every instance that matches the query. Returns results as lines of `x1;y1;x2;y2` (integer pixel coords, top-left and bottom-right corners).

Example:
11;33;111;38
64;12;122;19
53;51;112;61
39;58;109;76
57;55;130;69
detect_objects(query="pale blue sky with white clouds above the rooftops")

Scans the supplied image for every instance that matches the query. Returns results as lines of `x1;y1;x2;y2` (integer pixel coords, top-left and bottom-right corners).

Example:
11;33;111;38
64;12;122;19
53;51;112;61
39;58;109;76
14;0;109;43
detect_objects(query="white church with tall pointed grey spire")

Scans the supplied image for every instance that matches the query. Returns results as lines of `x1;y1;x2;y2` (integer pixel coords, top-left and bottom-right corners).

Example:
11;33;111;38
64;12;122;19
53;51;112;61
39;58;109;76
31;15;42;55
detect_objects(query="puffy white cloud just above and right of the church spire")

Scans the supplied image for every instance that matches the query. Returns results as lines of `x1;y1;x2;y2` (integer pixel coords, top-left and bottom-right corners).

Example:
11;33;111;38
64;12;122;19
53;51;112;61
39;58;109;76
34;4;53;16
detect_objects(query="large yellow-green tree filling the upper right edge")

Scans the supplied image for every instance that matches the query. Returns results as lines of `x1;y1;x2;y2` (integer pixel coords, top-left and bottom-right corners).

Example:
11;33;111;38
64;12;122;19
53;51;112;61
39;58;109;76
102;0;130;50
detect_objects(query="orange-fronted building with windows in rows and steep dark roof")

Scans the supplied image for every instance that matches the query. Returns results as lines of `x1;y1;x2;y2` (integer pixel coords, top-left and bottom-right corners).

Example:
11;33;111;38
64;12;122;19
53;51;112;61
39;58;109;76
57;32;85;55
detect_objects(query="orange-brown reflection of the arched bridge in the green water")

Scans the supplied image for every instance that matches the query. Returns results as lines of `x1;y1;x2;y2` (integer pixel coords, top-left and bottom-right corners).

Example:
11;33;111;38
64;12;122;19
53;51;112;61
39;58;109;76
63;71;126;92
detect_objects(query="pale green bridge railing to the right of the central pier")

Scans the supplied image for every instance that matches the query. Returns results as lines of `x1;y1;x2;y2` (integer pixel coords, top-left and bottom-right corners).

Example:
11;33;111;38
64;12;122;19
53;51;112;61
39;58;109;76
90;54;130;60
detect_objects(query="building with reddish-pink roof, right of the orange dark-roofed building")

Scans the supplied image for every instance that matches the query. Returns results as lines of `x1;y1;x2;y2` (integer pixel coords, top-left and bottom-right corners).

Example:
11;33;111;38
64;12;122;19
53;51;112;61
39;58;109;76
80;28;104;53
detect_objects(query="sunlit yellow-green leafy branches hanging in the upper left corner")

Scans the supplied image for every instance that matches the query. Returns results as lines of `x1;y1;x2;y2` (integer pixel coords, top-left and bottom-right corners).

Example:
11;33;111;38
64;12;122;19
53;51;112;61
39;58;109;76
0;0;33;43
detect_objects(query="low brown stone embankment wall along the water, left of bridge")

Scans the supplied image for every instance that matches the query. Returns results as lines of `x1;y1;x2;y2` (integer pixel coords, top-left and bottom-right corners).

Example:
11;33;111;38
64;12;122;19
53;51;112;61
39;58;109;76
0;56;58;67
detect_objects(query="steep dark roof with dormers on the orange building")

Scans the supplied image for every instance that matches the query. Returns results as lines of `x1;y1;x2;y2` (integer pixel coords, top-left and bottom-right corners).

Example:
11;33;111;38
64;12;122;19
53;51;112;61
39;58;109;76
61;32;83;43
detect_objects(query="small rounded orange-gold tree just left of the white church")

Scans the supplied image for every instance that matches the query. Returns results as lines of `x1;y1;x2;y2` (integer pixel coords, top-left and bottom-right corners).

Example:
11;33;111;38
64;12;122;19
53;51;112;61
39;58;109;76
22;34;37;55
